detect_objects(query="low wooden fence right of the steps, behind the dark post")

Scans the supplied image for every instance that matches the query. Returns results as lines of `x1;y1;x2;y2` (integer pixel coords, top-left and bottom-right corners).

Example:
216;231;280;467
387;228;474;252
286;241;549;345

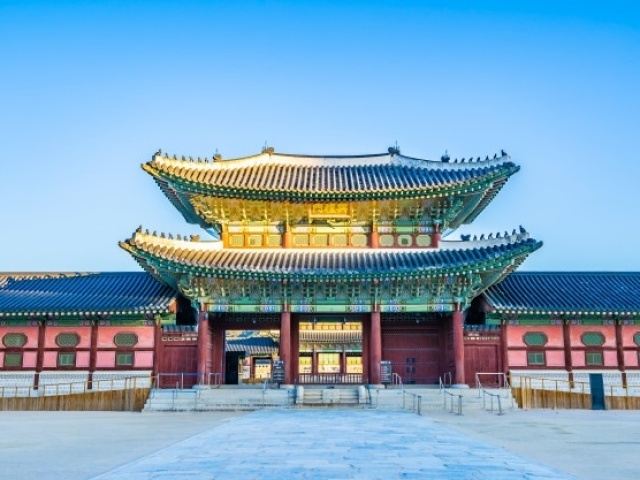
511;376;640;410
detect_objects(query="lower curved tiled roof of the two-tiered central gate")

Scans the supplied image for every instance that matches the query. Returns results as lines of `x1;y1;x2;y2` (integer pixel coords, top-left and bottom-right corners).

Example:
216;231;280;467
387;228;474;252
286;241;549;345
120;231;542;280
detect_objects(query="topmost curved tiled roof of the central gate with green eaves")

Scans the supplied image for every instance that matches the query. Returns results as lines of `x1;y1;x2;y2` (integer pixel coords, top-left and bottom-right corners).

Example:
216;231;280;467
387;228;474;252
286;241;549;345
142;149;520;228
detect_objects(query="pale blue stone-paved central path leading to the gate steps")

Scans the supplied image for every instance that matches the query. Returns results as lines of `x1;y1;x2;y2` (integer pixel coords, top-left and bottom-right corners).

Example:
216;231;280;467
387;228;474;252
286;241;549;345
90;410;570;480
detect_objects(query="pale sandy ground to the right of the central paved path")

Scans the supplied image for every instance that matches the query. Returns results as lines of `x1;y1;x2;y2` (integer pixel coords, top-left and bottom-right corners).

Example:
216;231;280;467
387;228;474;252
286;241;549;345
428;410;640;480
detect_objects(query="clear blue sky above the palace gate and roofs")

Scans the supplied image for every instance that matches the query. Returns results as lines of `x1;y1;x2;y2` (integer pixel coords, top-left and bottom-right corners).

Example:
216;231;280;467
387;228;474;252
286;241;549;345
0;0;640;271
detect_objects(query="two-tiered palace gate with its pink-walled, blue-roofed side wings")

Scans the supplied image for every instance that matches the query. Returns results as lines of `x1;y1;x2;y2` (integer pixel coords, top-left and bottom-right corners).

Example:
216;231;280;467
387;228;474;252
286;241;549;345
0;148;640;386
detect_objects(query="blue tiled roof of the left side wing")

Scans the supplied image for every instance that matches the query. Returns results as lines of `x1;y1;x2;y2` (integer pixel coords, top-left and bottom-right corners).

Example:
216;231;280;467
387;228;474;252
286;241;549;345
0;272;176;316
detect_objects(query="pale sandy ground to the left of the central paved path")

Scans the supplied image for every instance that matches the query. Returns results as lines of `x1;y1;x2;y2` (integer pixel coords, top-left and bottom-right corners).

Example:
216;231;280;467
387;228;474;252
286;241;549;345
0;412;245;480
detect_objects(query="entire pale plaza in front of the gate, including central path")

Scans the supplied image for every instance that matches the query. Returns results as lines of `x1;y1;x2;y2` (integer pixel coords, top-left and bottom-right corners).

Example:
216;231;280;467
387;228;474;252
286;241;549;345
0;408;640;480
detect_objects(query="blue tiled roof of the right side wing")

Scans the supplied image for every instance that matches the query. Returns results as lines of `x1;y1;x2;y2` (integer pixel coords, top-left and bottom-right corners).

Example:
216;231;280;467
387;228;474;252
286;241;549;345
485;272;640;314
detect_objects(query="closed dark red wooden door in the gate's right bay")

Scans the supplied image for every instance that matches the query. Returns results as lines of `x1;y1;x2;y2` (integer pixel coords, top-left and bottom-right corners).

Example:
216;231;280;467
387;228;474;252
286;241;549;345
382;327;440;384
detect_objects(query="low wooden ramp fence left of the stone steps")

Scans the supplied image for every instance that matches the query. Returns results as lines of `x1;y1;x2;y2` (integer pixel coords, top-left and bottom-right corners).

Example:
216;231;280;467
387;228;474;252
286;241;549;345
0;377;152;412
